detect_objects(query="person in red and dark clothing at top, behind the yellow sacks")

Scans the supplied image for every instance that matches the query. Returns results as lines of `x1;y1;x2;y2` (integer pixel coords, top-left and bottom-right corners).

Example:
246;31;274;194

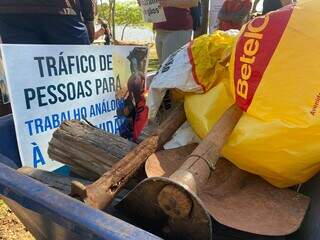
218;0;252;31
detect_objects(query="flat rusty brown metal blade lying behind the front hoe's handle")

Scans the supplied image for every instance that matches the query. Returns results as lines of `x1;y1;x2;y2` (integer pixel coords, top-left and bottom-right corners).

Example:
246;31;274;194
145;150;310;236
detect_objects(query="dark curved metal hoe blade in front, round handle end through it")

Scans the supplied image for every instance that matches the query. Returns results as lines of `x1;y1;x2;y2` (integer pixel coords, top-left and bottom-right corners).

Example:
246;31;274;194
117;177;212;240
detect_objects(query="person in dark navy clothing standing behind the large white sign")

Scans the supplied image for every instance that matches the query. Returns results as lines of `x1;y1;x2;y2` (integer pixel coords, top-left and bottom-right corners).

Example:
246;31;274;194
0;0;96;44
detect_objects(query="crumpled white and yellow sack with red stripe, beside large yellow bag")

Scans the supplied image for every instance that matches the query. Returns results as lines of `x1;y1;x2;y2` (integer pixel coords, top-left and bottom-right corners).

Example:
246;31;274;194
147;30;239;119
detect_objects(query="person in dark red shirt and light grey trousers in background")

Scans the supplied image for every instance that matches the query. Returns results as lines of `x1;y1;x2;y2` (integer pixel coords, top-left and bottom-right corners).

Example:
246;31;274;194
154;0;198;64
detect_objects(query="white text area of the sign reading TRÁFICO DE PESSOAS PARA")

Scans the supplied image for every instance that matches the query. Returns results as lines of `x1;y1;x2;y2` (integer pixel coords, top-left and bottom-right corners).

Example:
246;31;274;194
1;45;149;171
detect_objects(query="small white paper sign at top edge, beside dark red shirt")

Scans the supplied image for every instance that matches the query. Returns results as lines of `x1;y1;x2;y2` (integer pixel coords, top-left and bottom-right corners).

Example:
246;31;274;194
140;0;166;23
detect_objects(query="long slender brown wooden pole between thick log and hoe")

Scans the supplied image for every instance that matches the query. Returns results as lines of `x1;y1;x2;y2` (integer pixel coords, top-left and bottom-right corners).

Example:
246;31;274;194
72;104;186;209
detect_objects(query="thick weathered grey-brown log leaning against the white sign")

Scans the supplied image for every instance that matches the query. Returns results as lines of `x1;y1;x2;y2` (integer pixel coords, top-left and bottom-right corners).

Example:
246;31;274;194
48;120;137;179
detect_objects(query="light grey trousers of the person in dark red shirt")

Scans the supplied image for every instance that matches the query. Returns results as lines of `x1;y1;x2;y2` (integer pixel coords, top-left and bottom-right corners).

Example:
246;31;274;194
162;30;192;61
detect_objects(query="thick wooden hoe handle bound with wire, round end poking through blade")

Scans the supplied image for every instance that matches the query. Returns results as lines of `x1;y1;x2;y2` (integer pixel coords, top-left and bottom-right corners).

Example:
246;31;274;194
158;104;242;218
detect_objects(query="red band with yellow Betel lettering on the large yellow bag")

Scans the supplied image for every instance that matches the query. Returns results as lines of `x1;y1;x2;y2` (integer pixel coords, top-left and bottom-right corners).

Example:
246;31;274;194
234;6;293;111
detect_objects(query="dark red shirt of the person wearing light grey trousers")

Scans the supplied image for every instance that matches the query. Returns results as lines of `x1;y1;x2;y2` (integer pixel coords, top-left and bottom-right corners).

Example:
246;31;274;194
154;7;192;31
